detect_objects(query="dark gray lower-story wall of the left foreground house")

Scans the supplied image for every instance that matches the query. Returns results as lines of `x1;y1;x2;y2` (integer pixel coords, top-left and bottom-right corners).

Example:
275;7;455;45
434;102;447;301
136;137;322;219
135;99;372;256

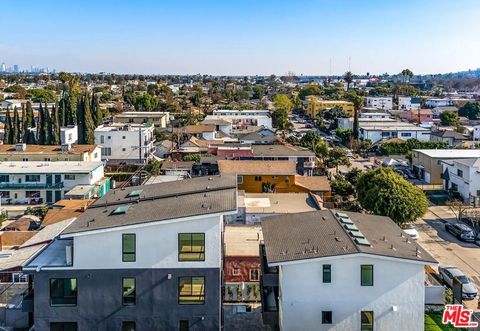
32;268;221;331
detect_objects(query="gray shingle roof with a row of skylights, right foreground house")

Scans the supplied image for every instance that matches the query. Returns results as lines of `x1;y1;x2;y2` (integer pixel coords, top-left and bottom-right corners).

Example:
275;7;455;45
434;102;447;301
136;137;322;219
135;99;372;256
262;210;437;263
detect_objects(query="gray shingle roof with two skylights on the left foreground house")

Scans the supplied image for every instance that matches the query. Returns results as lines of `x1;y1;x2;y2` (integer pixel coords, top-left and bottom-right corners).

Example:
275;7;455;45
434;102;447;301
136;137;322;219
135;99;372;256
62;175;237;237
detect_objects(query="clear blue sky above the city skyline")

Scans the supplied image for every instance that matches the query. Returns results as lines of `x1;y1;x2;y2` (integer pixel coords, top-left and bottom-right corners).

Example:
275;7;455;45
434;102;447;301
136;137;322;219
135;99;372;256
0;0;480;75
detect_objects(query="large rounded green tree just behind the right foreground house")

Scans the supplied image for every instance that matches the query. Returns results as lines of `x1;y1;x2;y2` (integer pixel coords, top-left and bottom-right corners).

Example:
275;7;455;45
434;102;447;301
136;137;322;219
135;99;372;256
357;167;428;225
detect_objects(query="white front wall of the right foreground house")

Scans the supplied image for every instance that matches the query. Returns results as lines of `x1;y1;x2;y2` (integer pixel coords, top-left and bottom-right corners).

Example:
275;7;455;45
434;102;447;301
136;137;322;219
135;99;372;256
279;256;425;331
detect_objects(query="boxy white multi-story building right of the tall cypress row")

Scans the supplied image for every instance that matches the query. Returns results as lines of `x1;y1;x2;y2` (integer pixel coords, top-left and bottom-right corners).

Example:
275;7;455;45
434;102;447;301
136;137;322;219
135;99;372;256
95;123;155;164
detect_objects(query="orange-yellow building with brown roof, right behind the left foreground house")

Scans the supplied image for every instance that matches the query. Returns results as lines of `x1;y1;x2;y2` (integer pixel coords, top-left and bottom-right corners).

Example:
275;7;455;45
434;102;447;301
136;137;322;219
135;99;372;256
217;160;331;196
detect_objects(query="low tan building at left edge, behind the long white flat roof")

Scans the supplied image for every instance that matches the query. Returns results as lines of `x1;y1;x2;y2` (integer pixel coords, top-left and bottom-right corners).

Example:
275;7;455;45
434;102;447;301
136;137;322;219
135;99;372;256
0;144;102;162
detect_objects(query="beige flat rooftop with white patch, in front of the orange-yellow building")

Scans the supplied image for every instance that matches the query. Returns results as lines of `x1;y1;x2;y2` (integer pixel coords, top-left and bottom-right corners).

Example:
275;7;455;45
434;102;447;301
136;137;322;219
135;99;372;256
238;193;318;214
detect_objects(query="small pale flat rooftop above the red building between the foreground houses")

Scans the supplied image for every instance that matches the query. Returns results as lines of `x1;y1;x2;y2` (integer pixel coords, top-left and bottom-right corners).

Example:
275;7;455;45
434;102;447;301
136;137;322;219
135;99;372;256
223;224;263;256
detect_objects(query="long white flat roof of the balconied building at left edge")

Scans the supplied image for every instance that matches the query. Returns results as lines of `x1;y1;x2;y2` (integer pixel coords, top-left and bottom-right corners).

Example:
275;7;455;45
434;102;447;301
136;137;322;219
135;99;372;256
0;161;103;174
